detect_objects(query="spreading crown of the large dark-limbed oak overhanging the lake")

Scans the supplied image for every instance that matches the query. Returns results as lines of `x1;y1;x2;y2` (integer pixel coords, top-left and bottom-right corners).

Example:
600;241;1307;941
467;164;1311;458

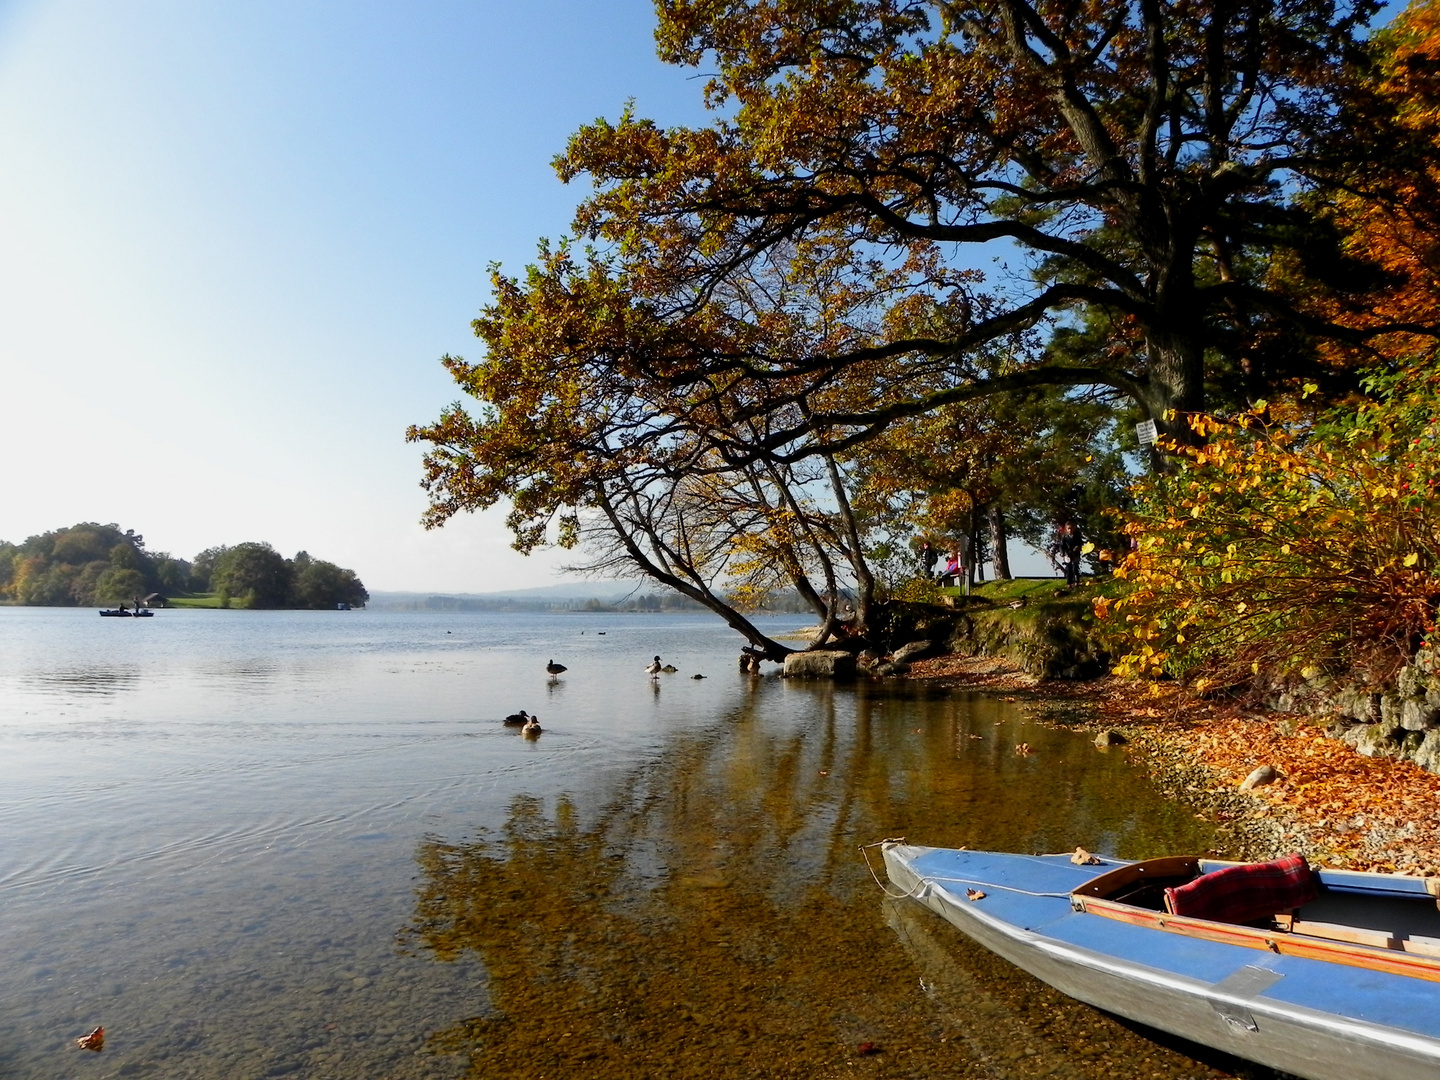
409;0;1433;650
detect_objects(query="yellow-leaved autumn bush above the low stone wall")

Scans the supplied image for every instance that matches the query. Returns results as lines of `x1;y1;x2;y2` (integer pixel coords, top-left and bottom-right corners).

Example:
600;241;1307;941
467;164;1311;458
1097;360;1440;687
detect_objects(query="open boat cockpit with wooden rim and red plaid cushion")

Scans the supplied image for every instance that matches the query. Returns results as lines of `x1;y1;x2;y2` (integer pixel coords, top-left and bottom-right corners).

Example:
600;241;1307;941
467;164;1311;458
1071;857;1440;981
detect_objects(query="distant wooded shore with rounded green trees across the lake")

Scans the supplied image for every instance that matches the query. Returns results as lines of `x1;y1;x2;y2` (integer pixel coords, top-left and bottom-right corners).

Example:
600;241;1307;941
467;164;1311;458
0;521;370;608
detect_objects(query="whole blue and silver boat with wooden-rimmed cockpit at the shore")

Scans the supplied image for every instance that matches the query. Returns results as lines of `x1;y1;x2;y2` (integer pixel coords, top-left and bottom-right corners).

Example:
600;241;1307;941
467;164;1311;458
884;842;1440;1080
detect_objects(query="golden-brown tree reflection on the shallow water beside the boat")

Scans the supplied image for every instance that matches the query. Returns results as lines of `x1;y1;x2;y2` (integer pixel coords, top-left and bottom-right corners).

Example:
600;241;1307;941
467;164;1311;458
412;693;1221;1077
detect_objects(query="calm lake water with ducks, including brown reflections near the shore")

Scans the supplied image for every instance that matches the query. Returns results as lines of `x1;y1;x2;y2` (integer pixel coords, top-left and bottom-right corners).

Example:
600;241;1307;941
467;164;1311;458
0;608;1249;1080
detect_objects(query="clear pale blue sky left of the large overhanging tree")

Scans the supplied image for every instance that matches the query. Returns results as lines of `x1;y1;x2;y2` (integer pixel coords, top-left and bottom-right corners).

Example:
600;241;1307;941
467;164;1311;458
0;0;717;592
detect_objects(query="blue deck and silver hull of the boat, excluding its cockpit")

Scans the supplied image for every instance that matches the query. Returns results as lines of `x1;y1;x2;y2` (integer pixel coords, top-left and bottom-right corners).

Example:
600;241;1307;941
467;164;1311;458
884;844;1440;1080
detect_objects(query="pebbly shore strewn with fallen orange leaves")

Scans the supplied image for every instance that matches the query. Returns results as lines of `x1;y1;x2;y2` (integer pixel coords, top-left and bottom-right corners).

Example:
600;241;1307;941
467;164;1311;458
904;655;1440;874
